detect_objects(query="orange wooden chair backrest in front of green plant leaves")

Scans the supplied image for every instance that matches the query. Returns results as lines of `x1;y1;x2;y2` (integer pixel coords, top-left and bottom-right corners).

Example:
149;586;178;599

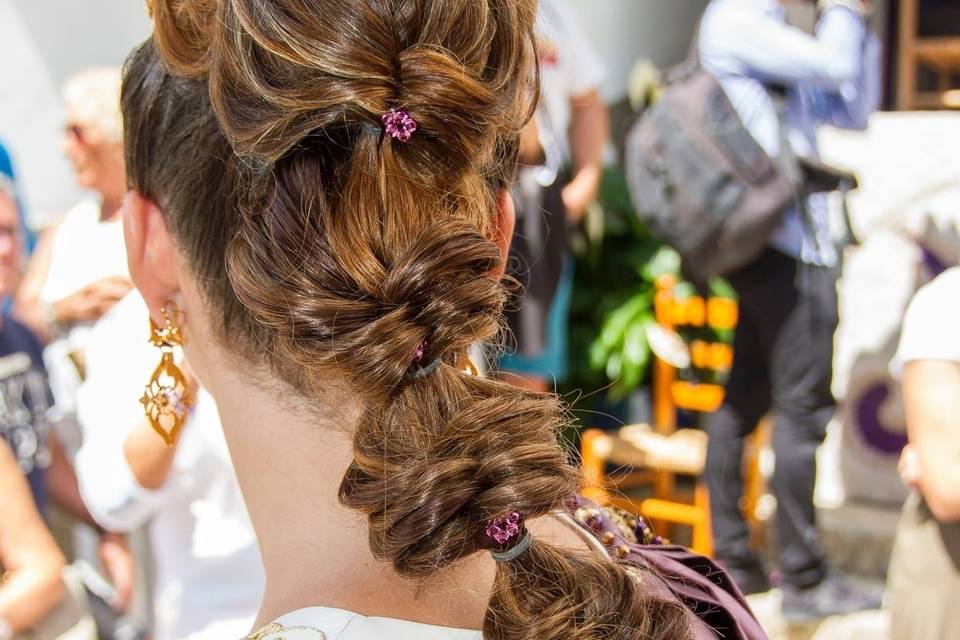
653;276;739;434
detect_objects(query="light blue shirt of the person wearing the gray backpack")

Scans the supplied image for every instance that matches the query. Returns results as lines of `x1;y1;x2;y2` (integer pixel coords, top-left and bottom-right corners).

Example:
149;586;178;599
700;0;881;265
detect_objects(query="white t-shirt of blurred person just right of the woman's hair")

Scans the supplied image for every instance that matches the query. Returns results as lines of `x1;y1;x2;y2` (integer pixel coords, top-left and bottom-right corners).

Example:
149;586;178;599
537;0;604;180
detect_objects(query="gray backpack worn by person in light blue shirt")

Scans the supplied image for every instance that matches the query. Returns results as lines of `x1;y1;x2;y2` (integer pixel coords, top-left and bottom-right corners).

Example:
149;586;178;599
625;58;807;282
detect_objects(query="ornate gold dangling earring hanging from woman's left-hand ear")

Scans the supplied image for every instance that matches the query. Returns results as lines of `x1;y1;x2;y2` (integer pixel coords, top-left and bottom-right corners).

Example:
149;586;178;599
140;302;194;447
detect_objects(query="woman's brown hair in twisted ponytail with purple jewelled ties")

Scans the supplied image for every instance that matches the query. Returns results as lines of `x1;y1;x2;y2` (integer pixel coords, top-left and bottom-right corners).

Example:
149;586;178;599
123;0;688;640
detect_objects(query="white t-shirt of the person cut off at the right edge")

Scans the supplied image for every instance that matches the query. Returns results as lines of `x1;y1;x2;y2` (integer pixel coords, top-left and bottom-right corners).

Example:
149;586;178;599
892;267;960;377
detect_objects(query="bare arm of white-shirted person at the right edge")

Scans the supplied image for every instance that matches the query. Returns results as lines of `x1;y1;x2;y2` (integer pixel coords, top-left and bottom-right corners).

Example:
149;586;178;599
903;360;960;522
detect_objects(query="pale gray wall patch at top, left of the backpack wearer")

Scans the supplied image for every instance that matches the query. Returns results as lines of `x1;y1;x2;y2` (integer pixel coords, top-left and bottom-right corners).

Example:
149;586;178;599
565;0;707;101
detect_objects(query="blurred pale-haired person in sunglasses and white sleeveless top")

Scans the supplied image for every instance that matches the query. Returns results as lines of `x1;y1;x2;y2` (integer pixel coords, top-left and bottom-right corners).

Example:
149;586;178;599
16;68;132;444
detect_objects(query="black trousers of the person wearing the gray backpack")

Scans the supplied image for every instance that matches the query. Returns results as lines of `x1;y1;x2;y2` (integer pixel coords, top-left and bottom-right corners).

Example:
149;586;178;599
706;249;837;588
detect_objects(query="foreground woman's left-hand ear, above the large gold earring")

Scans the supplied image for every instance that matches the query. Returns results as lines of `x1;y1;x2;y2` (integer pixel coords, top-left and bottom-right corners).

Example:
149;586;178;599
123;191;180;320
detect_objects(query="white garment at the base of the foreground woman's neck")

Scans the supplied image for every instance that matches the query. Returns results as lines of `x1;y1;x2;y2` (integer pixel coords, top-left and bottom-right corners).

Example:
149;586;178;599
248;607;483;640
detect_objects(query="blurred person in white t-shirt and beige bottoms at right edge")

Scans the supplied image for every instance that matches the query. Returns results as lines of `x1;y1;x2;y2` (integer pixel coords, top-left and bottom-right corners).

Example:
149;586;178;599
887;268;960;640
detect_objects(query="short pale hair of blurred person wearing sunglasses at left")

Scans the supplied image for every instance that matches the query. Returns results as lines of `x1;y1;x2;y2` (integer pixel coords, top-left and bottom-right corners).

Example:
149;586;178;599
63;67;123;143
